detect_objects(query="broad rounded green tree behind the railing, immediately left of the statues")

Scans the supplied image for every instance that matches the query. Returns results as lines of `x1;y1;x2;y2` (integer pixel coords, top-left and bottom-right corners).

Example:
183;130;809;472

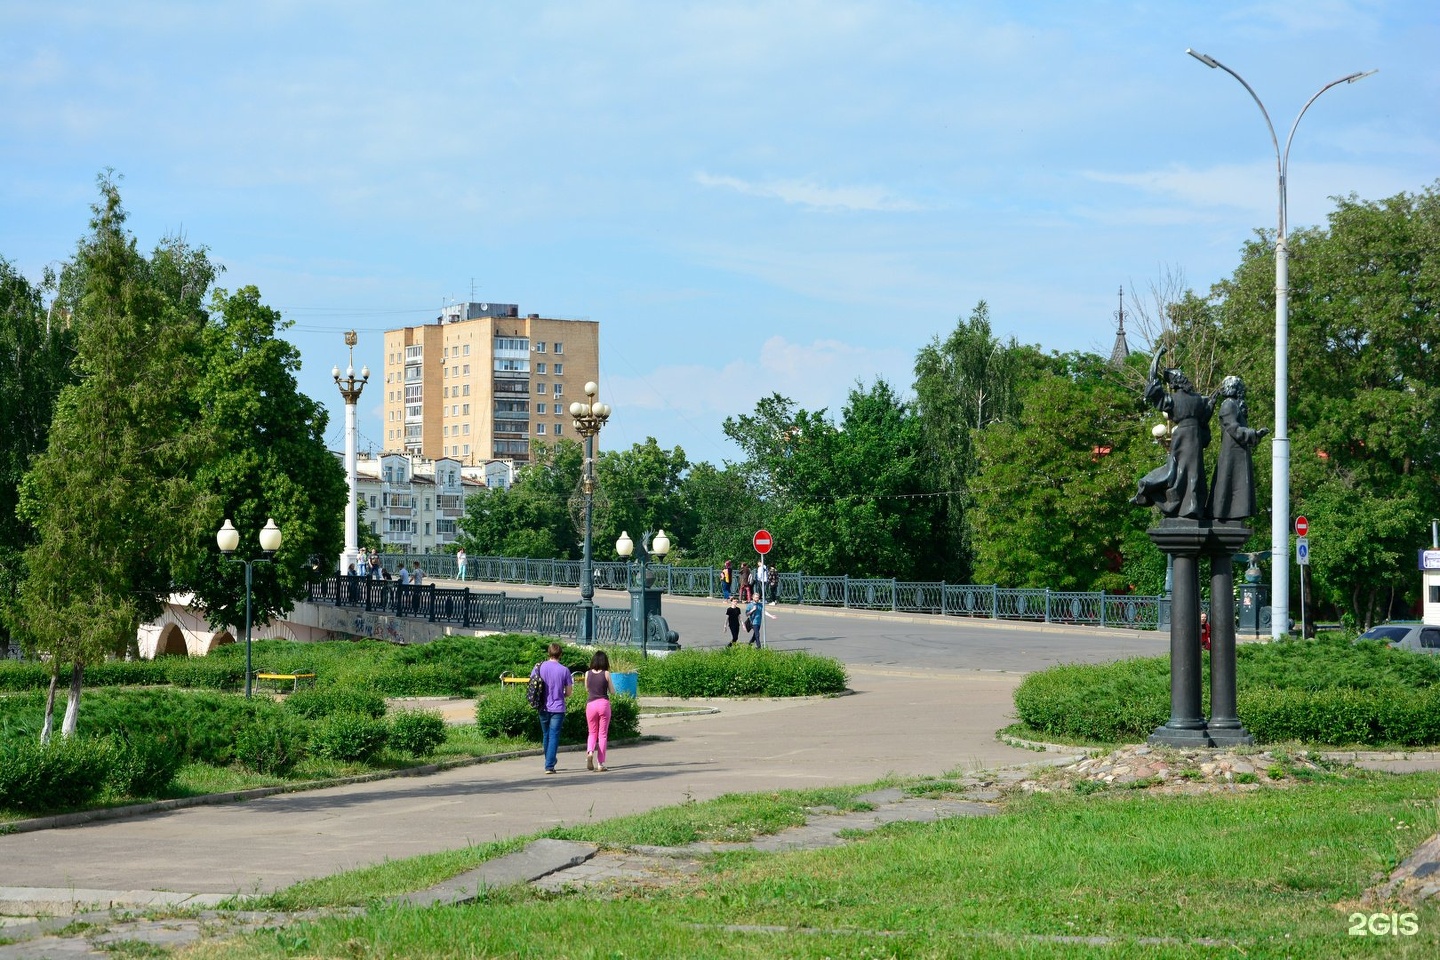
969;354;1164;592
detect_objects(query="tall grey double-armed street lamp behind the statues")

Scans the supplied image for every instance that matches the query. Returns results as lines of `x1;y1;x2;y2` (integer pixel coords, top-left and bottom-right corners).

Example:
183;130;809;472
1185;47;1378;639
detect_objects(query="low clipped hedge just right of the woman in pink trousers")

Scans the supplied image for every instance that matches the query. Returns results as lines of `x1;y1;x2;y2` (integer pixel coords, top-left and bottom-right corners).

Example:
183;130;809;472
639;646;847;697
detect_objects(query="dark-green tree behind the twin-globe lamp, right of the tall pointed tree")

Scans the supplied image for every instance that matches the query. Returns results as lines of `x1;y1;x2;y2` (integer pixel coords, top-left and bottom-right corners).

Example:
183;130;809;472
176;286;348;623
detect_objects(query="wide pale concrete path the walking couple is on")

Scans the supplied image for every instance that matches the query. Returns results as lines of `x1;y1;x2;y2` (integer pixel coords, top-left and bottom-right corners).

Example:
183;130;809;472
0;668;1037;908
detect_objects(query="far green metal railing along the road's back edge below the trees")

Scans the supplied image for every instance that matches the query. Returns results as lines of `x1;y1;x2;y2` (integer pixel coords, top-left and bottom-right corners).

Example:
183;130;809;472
365;554;1168;635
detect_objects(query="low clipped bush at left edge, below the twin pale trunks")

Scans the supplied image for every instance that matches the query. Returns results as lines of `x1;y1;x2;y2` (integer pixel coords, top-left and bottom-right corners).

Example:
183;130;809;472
0;737;115;812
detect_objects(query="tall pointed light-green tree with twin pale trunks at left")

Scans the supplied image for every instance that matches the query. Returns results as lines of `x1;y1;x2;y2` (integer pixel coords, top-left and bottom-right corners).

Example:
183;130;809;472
16;176;213;735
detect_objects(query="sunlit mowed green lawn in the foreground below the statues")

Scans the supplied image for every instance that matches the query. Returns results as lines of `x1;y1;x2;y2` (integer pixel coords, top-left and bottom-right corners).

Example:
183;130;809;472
180;771;1440;959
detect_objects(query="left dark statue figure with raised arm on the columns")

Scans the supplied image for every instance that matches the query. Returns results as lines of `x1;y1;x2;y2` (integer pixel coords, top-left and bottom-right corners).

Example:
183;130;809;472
1130;347;1215;522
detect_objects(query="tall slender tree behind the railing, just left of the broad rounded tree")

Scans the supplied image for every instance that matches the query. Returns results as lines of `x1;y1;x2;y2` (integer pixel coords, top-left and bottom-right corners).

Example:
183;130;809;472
914;301;1022;580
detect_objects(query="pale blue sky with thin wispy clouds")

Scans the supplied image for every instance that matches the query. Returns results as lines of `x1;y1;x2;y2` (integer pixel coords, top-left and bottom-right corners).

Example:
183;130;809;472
0;0;1440;465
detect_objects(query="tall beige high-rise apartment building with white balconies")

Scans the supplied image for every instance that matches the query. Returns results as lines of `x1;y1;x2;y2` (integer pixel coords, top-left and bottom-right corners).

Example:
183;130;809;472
384;302;600;465
